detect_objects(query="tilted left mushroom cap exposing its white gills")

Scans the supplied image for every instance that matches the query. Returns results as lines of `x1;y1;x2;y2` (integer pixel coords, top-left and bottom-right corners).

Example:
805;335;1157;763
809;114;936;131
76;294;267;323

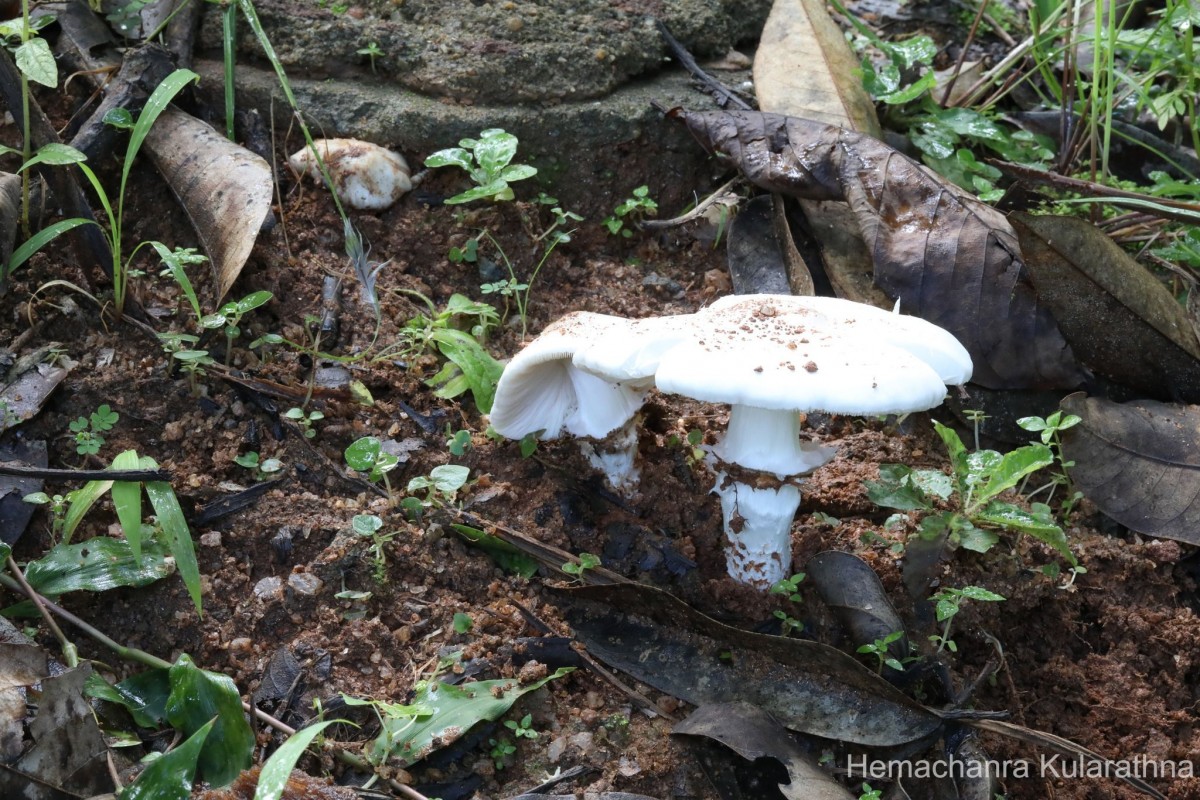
490;311;647;439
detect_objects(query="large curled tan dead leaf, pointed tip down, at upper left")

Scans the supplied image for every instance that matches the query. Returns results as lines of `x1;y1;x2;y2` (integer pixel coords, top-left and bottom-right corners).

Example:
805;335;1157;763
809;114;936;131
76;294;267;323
146;108;272;302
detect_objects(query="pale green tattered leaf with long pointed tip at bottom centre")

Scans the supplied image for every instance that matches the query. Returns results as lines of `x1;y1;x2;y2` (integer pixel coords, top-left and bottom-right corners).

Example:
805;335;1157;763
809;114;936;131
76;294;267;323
360;667;574;766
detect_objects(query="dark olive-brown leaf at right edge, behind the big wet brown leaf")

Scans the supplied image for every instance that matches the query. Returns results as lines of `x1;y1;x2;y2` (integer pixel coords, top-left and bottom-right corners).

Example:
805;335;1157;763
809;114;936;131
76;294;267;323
1013;213;1200;403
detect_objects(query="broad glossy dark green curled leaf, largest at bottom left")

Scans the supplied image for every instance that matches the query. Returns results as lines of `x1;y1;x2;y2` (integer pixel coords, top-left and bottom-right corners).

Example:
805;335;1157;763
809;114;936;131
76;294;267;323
167;654;254;787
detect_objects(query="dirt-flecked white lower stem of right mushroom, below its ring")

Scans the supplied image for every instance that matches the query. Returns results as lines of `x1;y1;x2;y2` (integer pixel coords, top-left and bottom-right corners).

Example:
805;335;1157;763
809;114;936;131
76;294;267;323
713;473;800;589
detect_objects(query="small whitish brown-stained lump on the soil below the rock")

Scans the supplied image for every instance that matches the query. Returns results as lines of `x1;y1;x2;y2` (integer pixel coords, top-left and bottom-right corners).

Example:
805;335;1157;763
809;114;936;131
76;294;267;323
288;139;413;211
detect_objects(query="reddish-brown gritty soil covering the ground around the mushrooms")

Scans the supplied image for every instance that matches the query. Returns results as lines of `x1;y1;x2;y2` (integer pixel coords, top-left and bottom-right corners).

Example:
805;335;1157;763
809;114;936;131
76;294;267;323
0;68;1200;800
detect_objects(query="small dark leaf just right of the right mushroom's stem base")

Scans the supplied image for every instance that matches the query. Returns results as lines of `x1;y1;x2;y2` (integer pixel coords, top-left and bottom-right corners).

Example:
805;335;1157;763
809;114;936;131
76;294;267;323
804;551;908;661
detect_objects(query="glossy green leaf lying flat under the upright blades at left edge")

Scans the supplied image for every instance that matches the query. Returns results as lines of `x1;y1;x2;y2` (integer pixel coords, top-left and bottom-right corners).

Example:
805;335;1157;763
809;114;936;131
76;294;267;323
25;536;172;597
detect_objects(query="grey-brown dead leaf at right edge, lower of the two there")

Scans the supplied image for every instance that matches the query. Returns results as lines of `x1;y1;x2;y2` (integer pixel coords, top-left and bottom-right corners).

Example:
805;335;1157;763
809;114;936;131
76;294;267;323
1062;393;1200;545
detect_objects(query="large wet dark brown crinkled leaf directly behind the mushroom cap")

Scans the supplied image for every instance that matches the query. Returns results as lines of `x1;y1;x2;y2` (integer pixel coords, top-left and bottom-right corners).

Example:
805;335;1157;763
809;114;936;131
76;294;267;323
679;112;1086;389
